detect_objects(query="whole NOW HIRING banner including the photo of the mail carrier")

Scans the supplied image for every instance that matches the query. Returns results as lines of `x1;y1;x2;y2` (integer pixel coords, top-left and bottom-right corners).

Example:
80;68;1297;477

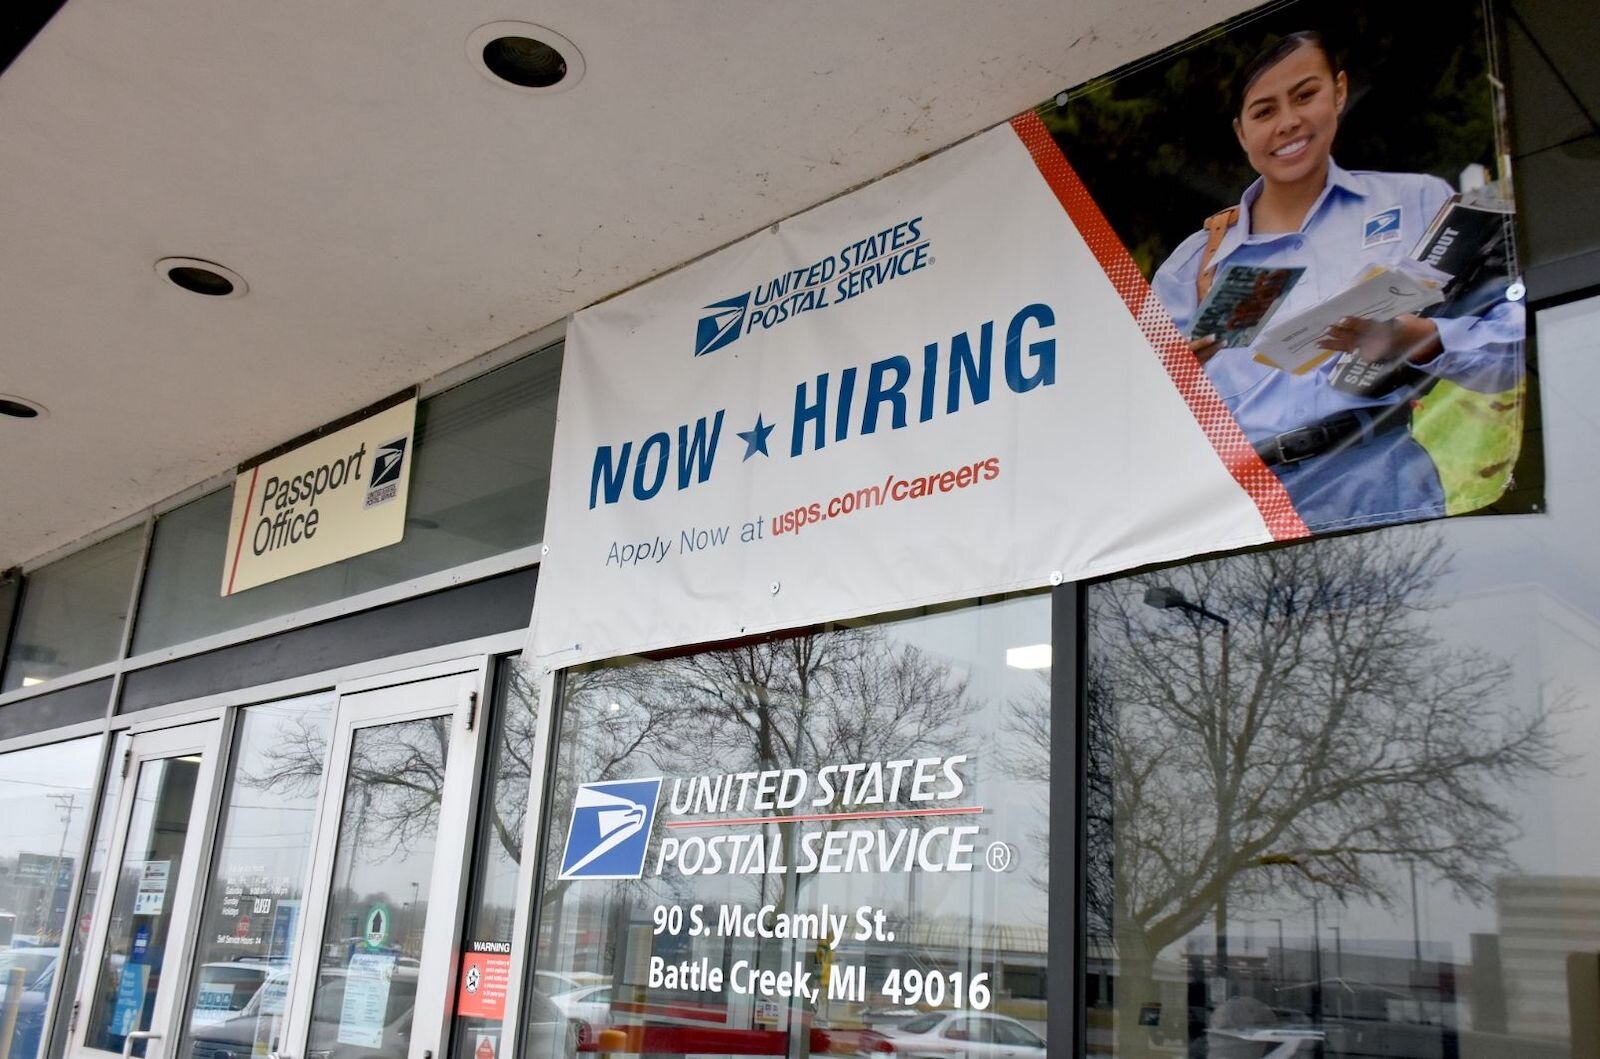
531;0;1542;669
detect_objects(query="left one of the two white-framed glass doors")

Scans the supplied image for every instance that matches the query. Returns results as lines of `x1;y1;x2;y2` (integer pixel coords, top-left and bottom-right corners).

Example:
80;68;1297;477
72;720;221;1059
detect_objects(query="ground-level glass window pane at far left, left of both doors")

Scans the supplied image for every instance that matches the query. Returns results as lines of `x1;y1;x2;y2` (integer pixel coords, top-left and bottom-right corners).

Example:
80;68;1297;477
0;736;104;1059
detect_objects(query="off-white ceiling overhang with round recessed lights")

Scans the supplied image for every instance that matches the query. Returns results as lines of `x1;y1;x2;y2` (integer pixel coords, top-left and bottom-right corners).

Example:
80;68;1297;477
0;0;1250;568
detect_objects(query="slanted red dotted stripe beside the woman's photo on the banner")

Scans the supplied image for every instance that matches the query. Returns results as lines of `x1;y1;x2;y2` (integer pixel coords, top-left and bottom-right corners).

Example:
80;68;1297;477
1011;112;1310;541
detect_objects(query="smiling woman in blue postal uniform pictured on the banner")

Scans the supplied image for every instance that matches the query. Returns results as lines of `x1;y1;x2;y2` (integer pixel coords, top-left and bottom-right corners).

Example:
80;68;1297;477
1150;22;1523;531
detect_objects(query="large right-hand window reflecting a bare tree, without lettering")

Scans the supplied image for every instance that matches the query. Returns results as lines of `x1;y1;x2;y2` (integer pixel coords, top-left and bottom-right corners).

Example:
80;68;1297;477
1085;301;1600;1059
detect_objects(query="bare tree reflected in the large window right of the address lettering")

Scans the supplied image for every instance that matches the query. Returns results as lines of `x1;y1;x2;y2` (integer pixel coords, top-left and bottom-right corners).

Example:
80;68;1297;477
1018;530;1557;1056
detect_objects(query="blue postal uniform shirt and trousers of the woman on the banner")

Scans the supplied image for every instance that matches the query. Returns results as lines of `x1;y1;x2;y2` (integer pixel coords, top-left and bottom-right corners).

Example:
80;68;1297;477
1150;162;1525;530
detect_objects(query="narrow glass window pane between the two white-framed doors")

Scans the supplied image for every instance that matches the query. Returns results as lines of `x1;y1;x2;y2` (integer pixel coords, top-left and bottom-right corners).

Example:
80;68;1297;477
176;694;334;1059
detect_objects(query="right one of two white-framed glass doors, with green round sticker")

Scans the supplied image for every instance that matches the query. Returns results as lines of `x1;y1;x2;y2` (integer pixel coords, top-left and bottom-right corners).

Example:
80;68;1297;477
275;669;483;1059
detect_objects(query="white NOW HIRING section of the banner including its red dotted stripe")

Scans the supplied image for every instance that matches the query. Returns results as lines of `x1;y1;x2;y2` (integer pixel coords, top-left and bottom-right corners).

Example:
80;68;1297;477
531;115;1306;667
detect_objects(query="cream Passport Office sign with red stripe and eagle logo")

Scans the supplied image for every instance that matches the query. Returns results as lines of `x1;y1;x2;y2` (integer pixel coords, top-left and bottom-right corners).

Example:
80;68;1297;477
222;394;416;595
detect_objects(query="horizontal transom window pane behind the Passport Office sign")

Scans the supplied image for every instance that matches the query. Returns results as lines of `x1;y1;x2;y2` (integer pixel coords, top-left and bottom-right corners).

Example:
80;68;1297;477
134;349;562;654
